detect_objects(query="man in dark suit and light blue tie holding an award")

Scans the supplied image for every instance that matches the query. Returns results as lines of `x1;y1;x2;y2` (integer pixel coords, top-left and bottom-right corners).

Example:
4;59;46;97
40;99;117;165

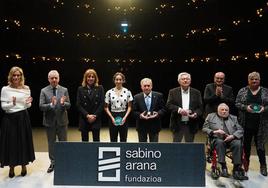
133;78;166;142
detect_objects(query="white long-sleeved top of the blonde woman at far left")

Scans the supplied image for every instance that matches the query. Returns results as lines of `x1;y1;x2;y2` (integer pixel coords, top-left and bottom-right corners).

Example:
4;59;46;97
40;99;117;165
1;86;31;113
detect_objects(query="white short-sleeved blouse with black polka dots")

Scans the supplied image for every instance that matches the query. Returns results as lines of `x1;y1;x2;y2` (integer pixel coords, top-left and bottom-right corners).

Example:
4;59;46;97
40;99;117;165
105;87;133;112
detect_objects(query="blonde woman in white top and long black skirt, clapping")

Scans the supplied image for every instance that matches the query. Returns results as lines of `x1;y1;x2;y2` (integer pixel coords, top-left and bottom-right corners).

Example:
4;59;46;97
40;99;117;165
0;67;35;178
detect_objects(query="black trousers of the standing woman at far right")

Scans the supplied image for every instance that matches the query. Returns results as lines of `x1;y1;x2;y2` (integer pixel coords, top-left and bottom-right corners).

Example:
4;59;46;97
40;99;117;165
244;128;266;165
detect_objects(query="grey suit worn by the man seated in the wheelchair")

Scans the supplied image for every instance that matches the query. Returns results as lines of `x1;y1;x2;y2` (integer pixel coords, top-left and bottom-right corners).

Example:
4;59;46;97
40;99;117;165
202;113;244;164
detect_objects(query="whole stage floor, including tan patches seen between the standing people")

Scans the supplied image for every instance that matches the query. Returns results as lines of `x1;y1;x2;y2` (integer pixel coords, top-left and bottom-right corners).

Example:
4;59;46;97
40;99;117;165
0;127;268;188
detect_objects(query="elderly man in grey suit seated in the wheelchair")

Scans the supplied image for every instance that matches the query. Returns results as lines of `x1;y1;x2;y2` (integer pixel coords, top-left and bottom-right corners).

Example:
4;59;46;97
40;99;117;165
202;103;248;180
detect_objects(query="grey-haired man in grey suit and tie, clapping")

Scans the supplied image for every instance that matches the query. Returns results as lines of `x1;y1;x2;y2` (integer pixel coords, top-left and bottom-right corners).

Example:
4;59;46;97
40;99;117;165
39;70;71;173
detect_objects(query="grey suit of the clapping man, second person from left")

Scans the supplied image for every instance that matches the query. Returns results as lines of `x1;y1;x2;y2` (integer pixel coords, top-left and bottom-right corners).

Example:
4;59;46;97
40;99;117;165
39;85;71;164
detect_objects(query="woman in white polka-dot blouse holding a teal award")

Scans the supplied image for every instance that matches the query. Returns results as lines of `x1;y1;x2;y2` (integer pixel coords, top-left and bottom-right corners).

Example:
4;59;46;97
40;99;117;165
104;72;133;142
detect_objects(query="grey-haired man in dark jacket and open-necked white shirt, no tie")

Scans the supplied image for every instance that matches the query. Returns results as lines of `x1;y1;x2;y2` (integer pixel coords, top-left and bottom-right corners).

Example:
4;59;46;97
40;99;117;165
166;72;203;142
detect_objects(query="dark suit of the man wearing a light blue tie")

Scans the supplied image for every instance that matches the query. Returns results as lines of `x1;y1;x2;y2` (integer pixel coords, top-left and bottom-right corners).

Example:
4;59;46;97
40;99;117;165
133;91;166;142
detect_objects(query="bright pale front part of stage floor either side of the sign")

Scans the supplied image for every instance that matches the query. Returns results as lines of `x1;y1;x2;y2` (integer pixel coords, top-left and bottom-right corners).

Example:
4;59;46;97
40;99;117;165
0;152;268;188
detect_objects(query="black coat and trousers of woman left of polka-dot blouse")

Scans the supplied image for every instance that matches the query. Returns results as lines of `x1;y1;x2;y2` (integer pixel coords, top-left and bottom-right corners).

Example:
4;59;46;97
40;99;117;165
76;85;104;141
